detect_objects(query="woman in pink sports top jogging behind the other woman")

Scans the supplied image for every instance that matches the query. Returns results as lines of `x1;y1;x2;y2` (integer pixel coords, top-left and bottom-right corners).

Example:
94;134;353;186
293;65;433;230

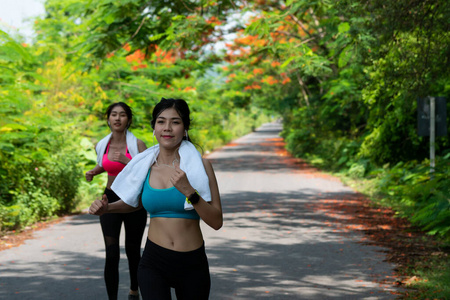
86;102;147;300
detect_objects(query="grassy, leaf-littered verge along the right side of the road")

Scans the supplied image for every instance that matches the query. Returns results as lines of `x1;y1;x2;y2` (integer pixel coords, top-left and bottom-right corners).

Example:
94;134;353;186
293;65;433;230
276;146;450;300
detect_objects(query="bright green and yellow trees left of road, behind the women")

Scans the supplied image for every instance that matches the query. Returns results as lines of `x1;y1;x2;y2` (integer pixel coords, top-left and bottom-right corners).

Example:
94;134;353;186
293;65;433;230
0;0;267;230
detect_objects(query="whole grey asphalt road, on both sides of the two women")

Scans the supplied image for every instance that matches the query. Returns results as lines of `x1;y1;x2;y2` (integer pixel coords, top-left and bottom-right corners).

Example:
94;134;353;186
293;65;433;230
0;123;395;300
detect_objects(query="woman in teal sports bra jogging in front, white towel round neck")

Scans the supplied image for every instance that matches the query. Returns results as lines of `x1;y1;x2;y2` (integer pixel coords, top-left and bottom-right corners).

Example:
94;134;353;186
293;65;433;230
89;99;223;300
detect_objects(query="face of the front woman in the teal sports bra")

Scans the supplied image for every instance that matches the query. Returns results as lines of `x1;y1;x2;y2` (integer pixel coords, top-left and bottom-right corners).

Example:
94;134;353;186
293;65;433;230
155;108;184;148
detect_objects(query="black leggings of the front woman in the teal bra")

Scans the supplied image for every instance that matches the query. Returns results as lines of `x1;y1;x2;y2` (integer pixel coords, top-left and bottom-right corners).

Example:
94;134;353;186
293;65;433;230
138;239;211;300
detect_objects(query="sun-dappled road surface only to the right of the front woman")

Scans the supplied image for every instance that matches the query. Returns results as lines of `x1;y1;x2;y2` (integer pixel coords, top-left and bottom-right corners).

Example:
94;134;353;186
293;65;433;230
204;124;399;299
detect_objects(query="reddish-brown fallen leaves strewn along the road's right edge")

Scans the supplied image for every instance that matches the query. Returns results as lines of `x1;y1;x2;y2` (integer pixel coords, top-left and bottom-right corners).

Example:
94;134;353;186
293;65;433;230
265;138;448;295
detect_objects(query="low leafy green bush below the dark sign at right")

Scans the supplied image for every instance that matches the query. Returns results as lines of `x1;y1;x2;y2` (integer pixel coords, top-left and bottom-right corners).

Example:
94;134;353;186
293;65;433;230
376;155;450;242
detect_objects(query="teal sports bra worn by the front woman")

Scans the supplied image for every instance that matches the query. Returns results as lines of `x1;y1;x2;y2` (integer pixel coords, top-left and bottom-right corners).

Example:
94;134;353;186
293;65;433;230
141;169;200;220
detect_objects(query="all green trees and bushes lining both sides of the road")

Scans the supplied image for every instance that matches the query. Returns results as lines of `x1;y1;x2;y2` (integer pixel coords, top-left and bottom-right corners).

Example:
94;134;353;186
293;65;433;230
0;0;450;262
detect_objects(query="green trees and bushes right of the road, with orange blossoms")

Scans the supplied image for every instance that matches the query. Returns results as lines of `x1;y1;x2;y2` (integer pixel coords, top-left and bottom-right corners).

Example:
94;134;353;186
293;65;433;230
236;0;450;241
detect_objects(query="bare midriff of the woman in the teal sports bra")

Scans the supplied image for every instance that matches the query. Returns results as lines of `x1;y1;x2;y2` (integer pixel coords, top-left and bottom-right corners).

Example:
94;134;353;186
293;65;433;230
148;218;203;252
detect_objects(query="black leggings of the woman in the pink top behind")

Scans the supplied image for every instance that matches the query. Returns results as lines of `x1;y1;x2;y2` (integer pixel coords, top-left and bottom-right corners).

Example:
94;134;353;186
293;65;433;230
100;189;147;300
